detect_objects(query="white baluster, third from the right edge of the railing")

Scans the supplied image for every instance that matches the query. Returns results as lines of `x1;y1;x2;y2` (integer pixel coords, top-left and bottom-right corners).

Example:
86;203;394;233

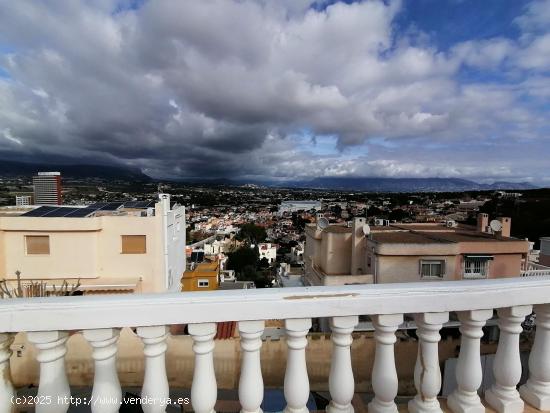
447;310;493;413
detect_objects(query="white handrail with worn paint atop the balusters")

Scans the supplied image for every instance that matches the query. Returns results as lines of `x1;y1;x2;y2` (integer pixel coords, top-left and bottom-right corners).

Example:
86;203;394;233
0;277;550;332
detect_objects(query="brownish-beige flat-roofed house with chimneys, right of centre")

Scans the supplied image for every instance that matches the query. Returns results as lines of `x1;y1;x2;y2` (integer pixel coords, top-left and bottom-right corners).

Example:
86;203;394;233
304;214;529;285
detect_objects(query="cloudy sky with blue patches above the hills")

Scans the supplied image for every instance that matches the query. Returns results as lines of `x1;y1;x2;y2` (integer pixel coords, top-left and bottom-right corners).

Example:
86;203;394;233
0;0;550;185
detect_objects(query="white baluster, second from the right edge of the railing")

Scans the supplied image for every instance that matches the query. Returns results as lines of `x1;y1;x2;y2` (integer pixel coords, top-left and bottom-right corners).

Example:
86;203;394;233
485;305;533;413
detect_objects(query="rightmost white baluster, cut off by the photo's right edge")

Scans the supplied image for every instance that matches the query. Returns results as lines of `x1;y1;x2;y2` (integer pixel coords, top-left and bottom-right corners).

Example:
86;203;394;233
519;304;550;410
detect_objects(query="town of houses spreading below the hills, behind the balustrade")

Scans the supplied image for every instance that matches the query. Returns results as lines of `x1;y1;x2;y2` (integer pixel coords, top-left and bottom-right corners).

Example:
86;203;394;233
0;171;550;409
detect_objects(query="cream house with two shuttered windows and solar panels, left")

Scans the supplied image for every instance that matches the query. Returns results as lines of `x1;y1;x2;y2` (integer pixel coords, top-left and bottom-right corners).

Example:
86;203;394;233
0;194;185;293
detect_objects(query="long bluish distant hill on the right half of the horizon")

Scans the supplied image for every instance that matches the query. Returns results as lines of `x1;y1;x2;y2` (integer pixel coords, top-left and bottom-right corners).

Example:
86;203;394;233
277;177;535;192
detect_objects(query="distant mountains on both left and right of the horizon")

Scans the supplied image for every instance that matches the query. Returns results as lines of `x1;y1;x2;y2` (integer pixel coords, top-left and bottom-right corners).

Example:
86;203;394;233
0;160;536;192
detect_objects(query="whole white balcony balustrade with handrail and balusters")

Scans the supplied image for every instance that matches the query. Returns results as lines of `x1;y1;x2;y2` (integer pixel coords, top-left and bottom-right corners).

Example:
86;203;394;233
0;277;550;413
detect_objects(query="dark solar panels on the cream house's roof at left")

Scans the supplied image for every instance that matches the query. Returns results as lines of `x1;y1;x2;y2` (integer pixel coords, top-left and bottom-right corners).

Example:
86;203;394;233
22;201;155;218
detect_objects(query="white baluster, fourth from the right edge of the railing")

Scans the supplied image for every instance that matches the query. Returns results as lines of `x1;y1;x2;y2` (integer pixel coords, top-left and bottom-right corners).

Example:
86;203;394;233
409;313;449;413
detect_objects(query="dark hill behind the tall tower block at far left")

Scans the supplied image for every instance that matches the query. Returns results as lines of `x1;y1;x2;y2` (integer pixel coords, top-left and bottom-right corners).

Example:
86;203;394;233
0;160;151;181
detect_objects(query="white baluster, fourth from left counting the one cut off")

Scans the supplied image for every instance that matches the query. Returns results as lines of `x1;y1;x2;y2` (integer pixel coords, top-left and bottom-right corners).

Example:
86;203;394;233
137;326;170;413
